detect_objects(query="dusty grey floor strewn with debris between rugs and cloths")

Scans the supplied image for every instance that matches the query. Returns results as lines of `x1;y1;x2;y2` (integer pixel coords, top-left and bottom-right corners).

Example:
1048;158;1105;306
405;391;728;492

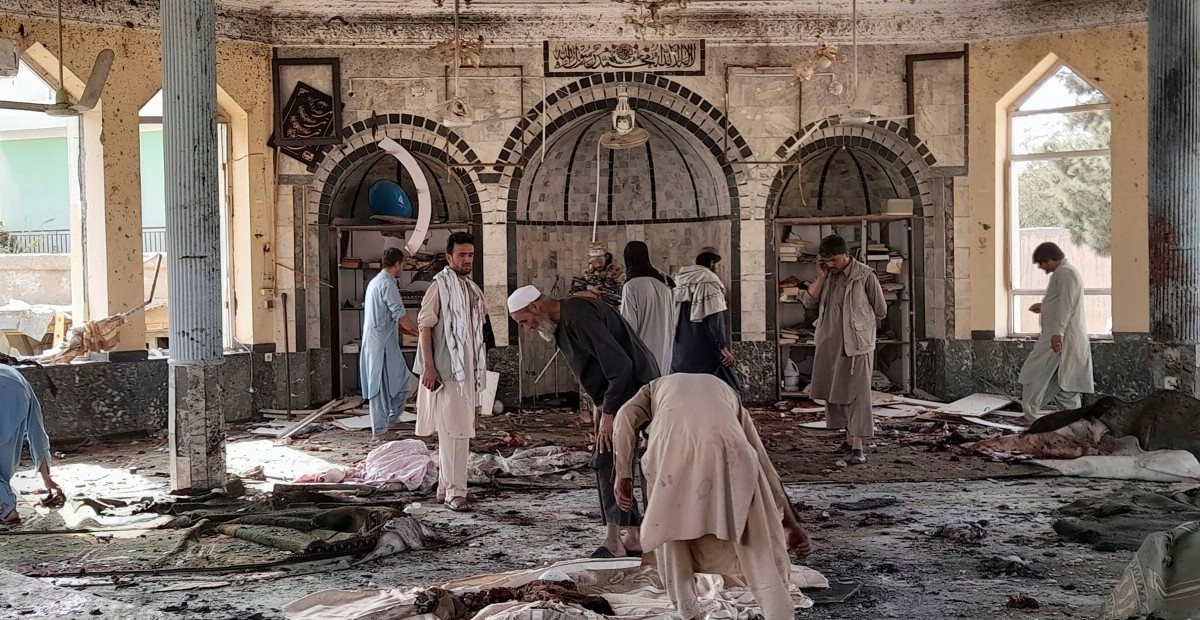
0;411;1159;620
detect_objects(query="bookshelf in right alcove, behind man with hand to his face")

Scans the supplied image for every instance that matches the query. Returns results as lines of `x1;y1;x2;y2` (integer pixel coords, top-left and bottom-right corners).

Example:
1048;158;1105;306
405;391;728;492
774;213;913;397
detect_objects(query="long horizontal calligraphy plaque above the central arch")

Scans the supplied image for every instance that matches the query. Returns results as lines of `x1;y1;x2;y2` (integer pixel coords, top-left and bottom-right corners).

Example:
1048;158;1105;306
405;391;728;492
542;40;704;78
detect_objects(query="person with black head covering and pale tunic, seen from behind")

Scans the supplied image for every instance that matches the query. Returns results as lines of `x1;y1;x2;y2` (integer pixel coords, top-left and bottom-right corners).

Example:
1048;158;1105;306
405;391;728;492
620;241;676;371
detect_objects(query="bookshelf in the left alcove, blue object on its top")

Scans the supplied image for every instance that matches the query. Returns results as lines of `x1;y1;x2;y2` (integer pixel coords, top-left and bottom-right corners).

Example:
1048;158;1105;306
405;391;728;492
330;218;472;397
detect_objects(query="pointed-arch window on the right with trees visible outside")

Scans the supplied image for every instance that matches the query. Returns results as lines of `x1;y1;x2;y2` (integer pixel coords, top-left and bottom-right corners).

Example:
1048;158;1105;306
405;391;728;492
1008;65;1112;335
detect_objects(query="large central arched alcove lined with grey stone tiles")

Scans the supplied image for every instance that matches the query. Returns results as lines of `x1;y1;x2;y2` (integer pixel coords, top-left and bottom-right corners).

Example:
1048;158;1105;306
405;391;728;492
500;74;744;397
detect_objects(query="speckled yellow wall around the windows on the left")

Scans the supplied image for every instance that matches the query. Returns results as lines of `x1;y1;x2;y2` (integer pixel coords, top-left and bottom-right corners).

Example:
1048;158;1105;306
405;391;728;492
0;14;275;350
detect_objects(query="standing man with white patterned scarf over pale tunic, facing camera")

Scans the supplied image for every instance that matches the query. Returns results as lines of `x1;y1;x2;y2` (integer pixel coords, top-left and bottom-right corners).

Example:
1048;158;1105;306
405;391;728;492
416;233;487;512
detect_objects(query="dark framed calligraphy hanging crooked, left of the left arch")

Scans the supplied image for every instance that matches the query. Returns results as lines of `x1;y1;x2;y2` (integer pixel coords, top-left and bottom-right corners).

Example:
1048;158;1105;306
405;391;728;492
271;58;342;149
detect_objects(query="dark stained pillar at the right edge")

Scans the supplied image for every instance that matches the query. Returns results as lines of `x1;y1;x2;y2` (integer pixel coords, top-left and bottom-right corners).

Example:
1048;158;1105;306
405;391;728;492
1142;0;1200;343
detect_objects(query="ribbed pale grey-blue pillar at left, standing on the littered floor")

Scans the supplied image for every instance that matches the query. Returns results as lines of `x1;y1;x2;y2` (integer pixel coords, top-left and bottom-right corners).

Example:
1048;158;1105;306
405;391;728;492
161;0;226;488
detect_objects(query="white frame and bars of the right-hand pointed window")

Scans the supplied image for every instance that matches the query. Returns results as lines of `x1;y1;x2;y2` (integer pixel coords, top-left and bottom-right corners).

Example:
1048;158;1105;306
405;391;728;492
1004;62;1112;341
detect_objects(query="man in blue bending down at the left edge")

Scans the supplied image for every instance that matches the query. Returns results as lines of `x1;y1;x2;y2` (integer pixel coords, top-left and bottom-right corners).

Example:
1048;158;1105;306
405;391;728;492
0;363;61;525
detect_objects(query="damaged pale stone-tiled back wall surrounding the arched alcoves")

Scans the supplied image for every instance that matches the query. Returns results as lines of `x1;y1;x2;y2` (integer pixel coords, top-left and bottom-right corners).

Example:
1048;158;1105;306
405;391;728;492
276;44;966;396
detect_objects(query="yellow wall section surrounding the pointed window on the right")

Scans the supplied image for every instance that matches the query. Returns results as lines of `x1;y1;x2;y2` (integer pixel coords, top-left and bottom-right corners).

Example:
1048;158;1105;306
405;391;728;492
955;26;1150;338
